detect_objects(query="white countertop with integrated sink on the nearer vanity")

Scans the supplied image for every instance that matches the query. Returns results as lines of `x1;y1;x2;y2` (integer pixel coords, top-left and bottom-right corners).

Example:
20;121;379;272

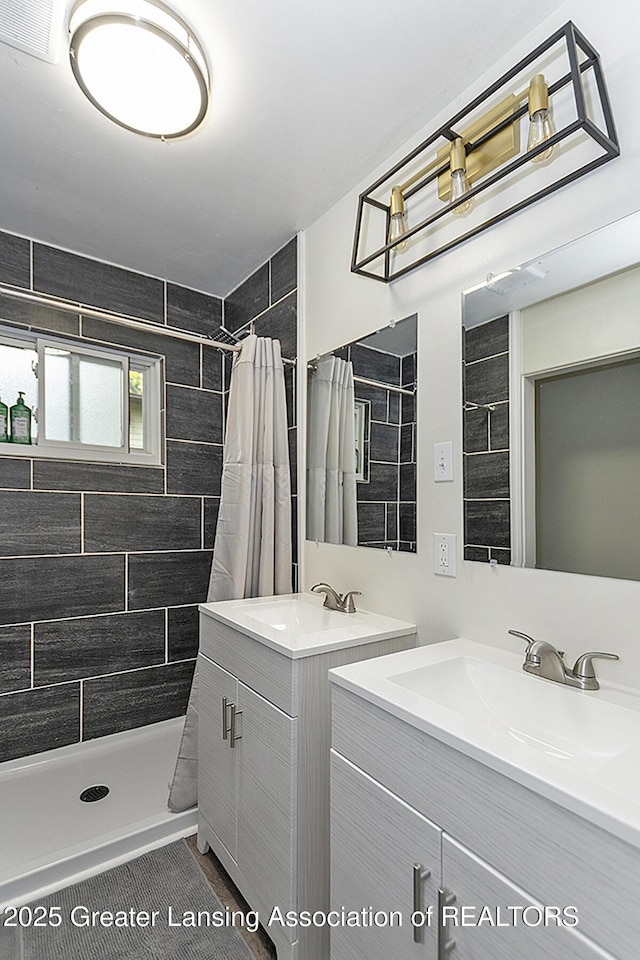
329;639;640;848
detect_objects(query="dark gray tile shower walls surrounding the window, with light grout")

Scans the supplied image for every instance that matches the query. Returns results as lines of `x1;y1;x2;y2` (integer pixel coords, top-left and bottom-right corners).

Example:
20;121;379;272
0;233;297;761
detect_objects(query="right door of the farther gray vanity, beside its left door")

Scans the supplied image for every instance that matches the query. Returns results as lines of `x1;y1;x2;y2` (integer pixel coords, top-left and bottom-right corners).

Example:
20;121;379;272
234;682;297;935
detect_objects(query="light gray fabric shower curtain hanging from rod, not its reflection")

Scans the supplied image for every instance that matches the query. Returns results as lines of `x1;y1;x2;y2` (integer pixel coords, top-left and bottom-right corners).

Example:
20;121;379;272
169;334;291;813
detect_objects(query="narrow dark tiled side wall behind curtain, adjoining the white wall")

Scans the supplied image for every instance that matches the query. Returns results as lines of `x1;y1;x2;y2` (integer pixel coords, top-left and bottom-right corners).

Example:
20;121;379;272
226;237;298;590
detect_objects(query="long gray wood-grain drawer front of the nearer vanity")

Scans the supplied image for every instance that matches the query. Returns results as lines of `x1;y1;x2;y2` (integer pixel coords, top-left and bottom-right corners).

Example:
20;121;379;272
332;684;640;960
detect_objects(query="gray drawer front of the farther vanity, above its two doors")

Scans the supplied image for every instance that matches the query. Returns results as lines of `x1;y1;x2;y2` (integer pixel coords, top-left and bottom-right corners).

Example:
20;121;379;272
200;613;298;717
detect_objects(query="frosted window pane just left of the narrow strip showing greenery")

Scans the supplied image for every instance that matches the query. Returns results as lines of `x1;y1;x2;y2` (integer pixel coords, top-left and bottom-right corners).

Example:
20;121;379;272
76;357;123;447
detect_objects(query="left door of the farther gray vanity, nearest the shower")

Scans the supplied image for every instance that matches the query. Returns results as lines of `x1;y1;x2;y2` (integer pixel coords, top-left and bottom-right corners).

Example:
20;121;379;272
198;654;237;860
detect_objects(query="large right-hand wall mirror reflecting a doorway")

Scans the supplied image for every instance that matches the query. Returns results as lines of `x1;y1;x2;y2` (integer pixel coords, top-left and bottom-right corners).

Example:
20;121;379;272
462;213;640;580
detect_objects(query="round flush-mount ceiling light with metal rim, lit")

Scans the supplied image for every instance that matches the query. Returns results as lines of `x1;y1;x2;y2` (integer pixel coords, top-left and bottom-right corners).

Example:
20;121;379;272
69;0;209;140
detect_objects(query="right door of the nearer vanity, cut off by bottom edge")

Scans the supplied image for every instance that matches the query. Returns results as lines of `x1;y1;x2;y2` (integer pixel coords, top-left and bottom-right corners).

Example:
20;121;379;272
442;834;612;960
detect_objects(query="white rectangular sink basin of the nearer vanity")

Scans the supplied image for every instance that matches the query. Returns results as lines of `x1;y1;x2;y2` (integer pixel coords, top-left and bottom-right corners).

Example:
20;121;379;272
389;656;640;767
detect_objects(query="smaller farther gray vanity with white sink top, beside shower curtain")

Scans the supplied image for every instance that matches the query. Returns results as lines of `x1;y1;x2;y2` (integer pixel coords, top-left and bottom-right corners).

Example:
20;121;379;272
198;597;416;960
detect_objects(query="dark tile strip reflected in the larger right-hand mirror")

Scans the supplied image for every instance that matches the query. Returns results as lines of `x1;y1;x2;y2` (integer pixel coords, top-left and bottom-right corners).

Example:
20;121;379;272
462;317;511;563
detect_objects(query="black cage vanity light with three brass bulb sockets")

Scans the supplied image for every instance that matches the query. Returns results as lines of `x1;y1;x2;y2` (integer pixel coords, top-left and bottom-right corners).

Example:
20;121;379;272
351;22;620;283
